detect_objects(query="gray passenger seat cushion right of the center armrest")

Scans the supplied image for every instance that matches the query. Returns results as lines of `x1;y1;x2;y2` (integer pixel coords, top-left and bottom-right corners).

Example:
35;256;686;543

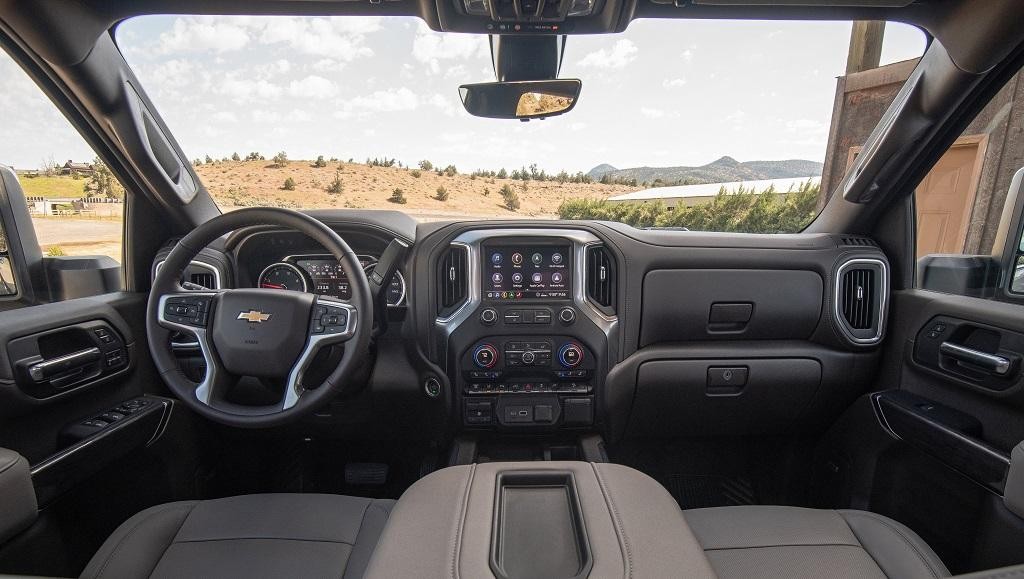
685;506;949;579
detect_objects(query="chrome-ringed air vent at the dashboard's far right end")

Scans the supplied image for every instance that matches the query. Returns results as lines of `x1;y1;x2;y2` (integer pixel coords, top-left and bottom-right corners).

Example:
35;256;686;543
836;259;888;344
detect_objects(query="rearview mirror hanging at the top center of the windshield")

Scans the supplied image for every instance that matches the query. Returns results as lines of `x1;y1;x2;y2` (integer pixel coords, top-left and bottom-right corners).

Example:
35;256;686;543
459;79;583;121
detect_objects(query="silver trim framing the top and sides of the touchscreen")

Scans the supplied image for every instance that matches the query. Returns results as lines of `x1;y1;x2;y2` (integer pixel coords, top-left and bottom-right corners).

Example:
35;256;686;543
434;228;618;339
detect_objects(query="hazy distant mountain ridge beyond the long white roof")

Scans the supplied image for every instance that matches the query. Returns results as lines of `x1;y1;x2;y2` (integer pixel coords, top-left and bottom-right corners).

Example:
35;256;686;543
588;157;823;184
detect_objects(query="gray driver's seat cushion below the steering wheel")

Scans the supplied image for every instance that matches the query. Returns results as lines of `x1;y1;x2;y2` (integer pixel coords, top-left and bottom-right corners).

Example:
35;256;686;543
82;494;394;579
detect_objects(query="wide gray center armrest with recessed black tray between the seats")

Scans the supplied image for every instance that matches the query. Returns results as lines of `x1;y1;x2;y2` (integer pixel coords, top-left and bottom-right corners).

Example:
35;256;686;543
366;461;715;579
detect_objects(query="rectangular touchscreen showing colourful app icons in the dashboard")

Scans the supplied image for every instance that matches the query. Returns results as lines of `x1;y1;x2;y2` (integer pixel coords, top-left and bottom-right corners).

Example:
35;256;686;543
482;245;572;300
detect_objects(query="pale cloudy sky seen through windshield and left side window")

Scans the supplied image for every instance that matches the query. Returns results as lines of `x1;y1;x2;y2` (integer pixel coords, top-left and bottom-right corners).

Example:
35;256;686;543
0;15;925;172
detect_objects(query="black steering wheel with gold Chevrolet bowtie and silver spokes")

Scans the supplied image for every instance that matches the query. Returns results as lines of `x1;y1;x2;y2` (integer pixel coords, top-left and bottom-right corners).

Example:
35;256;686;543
146;207;374;428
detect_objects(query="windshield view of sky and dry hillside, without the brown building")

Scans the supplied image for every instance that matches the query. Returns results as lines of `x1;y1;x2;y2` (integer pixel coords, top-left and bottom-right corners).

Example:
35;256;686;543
110;16;925;228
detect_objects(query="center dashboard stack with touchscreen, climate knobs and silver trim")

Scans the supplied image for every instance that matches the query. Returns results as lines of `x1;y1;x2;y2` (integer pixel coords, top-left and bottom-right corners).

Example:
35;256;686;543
436;229;617;431
